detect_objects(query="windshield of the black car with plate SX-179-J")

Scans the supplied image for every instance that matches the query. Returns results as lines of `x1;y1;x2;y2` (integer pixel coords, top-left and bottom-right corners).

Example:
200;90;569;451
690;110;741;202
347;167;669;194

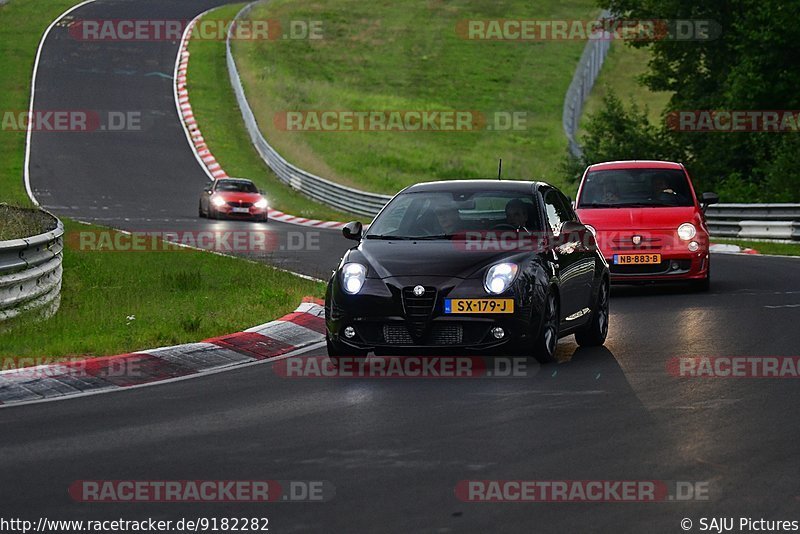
365;191;540;239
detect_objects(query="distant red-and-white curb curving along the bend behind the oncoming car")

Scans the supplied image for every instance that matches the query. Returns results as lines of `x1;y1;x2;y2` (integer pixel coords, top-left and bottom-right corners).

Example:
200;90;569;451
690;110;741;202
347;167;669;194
175;13;345;230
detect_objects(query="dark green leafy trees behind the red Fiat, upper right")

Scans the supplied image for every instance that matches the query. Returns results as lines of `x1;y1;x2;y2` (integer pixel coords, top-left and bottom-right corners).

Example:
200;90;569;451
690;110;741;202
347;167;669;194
586;0;800;201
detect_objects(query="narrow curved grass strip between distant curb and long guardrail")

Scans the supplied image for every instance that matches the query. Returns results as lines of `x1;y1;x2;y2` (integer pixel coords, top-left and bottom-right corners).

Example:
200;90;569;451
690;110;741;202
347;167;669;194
188;4;356;221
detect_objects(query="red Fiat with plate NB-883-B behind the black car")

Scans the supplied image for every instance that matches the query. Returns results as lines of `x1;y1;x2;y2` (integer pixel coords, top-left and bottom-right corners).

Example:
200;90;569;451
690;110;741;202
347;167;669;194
575;160;719;291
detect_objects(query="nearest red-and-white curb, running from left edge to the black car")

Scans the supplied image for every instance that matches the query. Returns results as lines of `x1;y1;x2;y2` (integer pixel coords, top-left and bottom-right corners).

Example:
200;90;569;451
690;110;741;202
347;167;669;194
0;297;325;408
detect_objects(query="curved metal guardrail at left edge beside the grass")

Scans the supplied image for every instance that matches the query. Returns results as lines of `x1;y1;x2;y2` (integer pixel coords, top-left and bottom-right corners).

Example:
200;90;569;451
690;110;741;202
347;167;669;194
0;213;64;321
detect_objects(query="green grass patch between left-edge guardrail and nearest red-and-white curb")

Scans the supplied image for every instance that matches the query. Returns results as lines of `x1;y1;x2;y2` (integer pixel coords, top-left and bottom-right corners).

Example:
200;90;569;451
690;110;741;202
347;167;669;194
0;221;324;358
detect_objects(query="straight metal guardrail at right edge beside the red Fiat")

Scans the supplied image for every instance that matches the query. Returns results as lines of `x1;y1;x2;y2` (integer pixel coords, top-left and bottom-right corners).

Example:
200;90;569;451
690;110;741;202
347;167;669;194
706;204;800;242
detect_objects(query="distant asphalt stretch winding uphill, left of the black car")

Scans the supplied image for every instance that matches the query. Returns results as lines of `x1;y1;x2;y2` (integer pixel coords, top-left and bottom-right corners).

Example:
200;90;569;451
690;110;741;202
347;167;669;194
30;0;348;279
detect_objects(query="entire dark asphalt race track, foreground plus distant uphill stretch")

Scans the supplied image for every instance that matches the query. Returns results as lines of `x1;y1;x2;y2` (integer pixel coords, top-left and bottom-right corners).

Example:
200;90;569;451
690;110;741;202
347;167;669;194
12;0;800;533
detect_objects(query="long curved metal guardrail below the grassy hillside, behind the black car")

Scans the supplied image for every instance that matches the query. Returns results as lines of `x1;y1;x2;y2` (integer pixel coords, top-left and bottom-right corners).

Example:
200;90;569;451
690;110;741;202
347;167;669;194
226;2;392;217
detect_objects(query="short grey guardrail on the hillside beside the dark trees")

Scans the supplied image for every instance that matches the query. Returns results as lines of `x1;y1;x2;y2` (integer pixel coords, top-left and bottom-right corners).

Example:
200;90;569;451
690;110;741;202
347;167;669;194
561;10;611;158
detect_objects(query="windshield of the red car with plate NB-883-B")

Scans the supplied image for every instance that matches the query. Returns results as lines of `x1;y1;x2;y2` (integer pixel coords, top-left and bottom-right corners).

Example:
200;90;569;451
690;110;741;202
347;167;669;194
578;169;694;208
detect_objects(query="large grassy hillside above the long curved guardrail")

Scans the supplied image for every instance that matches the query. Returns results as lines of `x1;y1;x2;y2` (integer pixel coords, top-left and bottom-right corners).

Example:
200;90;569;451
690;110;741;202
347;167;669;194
228;0;598;193
